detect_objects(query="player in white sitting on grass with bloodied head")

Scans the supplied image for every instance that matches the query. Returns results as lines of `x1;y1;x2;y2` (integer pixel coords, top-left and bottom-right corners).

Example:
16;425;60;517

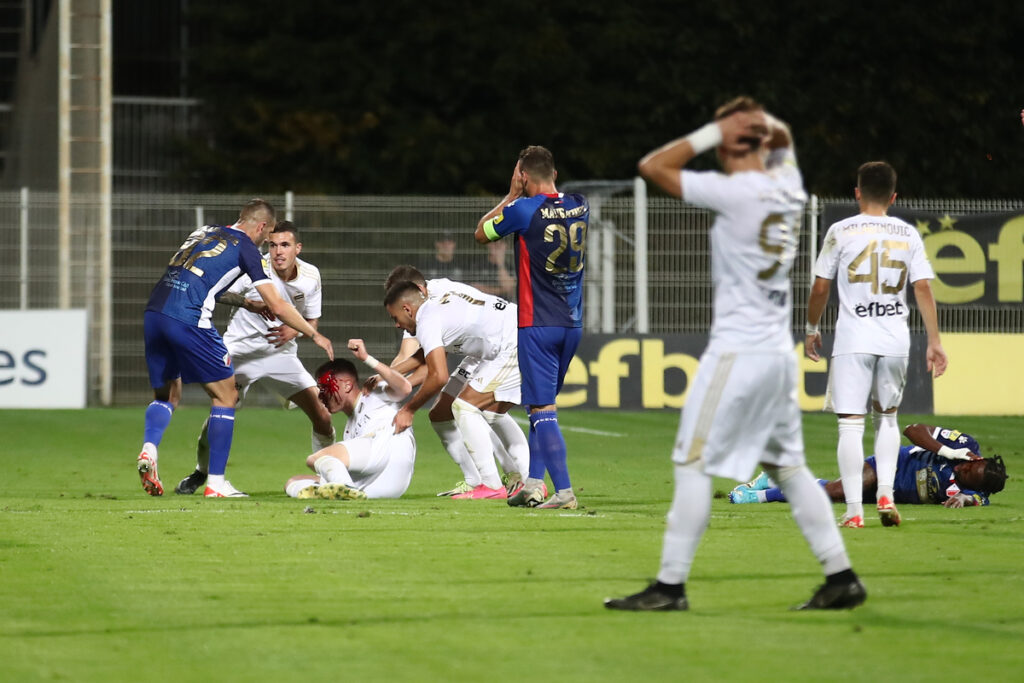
285;339;416;500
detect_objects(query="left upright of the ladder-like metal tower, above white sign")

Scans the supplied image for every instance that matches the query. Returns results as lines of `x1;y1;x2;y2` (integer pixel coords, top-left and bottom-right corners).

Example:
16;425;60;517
57;0;72;308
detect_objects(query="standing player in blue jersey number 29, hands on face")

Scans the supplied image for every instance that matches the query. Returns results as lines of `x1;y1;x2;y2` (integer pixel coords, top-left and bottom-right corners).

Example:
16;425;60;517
475;145;590;509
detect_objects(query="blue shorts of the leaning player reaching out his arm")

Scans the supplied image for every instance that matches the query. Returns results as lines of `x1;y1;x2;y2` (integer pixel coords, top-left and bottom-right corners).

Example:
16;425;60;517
143;310;234;389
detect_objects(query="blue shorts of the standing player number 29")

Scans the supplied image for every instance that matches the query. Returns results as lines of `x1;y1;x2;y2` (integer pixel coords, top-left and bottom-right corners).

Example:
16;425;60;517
519;328;583;407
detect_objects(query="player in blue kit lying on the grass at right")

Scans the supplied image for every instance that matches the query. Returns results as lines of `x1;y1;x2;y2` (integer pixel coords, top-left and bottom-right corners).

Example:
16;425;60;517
729;424;1008;508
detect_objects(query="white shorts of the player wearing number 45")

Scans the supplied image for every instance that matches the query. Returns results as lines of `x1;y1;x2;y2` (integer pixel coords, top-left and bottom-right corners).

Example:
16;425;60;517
824;353;908;415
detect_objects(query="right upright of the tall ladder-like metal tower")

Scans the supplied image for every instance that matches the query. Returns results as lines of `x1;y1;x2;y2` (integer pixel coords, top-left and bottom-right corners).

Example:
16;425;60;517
99;0;114;405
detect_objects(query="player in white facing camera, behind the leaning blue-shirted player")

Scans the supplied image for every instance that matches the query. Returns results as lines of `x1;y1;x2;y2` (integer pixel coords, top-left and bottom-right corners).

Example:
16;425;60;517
174;220;335;494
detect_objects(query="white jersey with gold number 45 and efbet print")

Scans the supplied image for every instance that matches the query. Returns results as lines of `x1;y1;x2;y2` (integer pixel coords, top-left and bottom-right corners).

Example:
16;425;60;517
814;214;935;356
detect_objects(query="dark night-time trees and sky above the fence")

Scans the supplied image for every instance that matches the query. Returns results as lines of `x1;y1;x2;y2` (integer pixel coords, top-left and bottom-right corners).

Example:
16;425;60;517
115;0;1024;199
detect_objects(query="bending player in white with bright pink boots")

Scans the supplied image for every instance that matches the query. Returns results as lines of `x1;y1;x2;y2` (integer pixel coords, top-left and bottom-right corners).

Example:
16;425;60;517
384;281;529;500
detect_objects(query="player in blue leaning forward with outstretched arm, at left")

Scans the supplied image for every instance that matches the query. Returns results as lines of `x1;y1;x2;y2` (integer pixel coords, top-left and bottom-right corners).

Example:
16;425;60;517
136;199;334;498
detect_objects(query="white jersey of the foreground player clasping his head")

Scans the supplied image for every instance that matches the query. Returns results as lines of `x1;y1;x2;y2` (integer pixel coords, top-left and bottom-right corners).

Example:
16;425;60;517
681;147;807;353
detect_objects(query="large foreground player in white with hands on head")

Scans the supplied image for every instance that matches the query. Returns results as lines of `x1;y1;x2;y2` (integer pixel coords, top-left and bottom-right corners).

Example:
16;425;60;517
604;97;866;611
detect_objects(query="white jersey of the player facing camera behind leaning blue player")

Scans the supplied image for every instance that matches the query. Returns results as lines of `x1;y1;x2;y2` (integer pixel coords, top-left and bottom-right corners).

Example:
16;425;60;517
224;256;322;356
